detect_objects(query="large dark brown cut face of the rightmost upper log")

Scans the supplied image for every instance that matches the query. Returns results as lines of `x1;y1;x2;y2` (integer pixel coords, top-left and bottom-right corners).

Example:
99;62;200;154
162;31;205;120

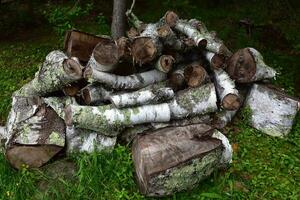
227;48;256;82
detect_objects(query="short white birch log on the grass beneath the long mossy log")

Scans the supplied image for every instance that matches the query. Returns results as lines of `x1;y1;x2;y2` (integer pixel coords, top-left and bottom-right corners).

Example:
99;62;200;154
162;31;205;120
66;126;117;154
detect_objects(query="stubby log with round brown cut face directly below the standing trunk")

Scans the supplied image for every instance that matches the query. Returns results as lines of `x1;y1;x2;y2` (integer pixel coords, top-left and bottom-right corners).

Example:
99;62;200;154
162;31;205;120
87;37;120;72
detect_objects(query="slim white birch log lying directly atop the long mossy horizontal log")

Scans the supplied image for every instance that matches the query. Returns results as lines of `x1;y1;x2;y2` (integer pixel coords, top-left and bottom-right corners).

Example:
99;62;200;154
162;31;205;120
109;88;174;108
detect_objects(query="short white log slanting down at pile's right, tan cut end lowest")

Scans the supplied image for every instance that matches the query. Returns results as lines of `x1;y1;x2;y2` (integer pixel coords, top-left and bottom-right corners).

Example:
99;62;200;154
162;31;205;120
214;69;241;110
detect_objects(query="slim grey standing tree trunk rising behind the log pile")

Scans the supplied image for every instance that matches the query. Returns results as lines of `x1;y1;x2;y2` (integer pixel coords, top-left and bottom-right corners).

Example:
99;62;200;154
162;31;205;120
111;0;126;40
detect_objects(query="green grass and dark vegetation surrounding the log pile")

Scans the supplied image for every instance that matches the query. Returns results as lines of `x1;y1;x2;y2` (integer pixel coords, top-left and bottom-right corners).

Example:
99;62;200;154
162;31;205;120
0;0;300;199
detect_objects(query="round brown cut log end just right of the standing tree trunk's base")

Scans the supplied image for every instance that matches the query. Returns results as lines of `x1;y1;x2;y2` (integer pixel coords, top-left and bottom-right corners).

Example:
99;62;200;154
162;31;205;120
132;37;157;64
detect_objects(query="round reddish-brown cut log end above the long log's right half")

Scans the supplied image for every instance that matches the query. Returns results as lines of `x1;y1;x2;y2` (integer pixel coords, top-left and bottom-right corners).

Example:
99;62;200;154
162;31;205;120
184;65;208;87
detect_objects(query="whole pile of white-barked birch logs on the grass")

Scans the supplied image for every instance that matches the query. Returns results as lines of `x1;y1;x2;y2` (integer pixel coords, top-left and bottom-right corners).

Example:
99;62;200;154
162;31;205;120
2;10;299;196
